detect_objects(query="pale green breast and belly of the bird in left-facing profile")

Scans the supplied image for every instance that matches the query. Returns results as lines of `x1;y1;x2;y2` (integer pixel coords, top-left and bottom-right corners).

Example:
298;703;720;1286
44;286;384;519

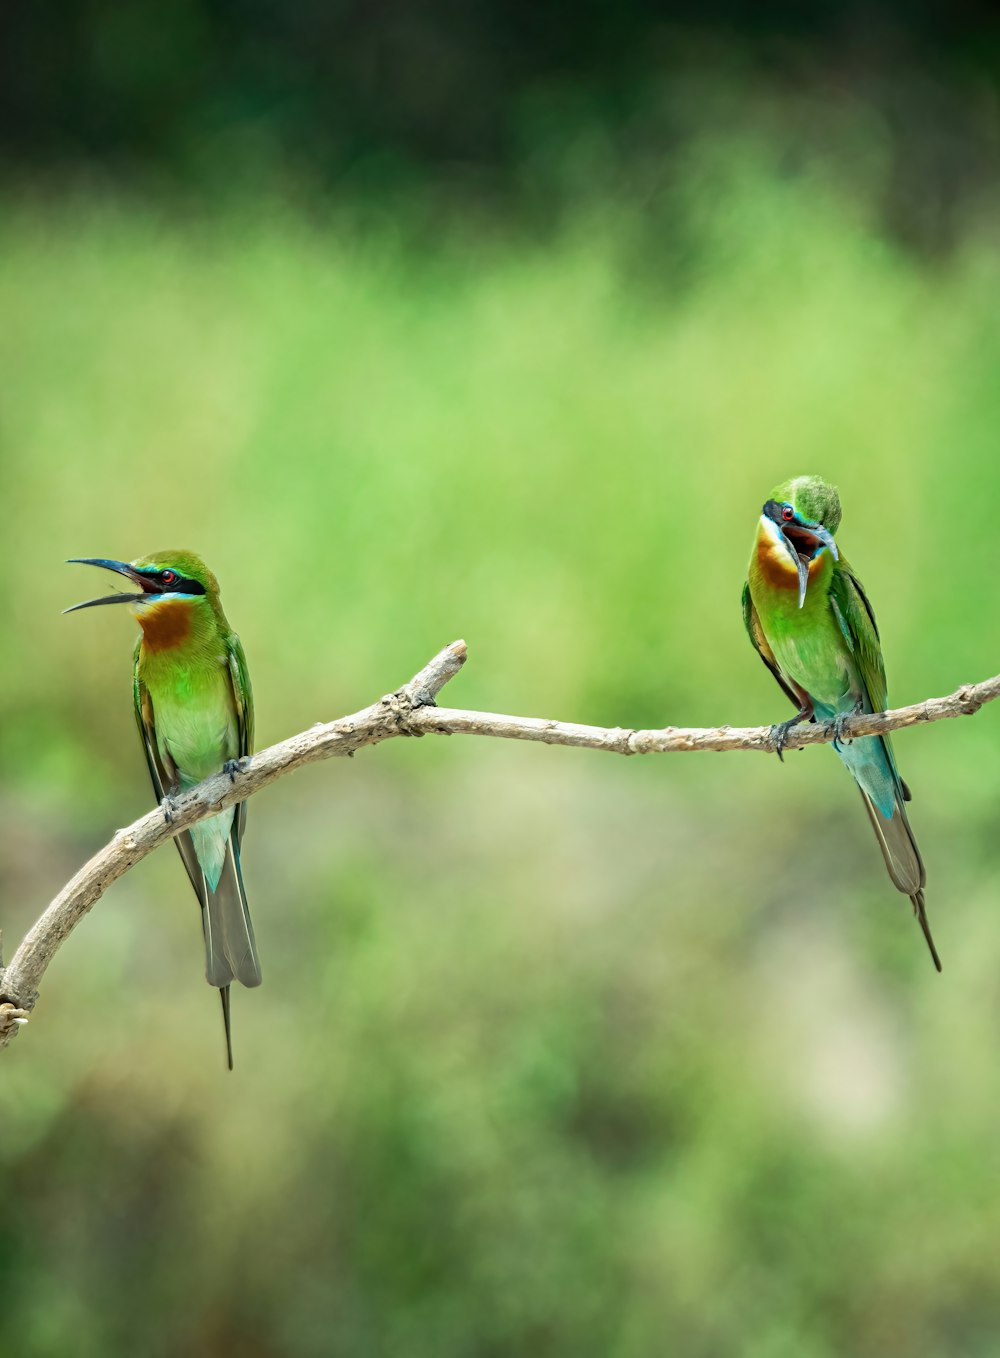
149;668;239;784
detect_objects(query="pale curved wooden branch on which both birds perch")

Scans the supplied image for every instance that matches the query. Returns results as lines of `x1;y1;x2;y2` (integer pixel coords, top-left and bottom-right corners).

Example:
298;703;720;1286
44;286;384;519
0;641;1000;1047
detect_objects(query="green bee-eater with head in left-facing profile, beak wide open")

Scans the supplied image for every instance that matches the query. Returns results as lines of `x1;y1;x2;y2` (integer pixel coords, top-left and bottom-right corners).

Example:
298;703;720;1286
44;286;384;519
67;551;261;1070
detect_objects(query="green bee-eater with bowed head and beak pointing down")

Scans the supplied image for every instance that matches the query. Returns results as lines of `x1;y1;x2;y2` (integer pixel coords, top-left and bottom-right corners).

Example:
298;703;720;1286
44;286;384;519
743;477;942;971
